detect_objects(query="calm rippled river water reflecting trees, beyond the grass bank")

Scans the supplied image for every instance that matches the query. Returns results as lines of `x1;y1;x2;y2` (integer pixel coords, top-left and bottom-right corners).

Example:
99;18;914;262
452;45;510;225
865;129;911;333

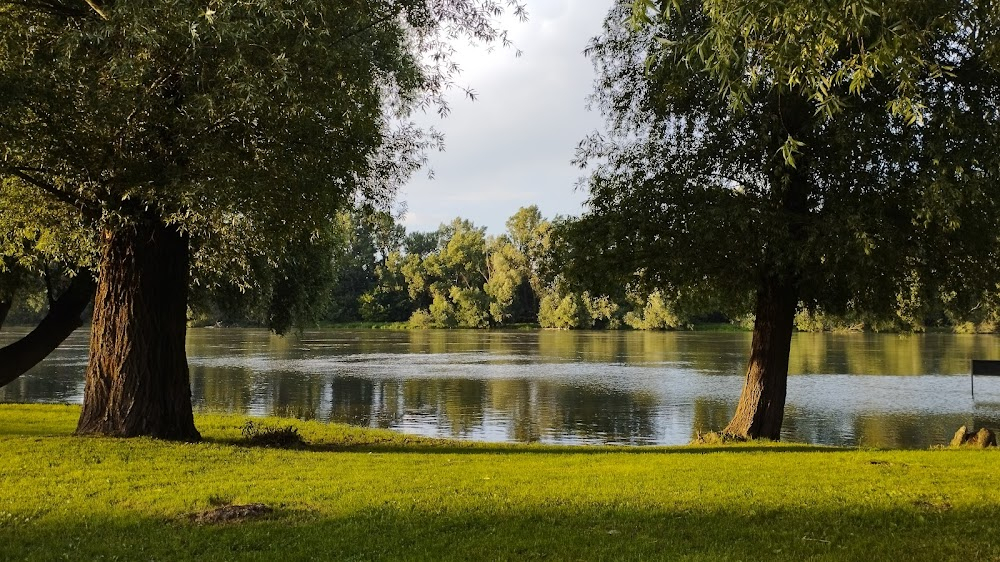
0;329;1000;448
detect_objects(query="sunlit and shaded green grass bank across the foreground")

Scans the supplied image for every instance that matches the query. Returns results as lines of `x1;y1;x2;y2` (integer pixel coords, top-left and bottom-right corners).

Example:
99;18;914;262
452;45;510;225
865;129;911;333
0;405;1000;561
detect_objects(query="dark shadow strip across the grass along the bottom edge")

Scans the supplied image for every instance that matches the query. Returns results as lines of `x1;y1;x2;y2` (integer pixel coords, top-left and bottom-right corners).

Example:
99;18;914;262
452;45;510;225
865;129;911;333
0;500;1000;561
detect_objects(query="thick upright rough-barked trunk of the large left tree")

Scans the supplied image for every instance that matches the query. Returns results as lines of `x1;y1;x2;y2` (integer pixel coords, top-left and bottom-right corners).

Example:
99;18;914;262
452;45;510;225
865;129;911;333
76;220;201;440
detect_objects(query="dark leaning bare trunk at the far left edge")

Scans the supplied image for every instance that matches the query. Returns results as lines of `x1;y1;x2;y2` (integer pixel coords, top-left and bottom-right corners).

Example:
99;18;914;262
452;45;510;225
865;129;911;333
0;271;94;387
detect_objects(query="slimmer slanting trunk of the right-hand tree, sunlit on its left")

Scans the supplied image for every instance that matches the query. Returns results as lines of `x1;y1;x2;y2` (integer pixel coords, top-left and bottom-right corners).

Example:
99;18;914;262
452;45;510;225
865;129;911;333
722;278;798;441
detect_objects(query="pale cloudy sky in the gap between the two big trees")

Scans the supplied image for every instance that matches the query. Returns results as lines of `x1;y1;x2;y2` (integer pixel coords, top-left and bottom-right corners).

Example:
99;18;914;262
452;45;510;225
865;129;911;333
399;0;611;234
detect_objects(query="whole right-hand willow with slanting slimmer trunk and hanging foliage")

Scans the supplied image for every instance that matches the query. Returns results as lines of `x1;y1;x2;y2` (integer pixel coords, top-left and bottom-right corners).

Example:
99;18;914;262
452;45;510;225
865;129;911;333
571;0;1000;439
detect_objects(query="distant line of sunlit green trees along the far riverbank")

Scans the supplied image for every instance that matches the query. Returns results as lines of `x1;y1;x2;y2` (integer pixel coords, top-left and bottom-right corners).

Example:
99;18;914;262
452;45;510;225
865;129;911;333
178;206;997;332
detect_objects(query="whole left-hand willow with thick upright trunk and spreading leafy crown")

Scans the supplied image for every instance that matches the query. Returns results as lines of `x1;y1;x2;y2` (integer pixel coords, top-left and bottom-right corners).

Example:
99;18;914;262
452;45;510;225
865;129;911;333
0;0;521;439
